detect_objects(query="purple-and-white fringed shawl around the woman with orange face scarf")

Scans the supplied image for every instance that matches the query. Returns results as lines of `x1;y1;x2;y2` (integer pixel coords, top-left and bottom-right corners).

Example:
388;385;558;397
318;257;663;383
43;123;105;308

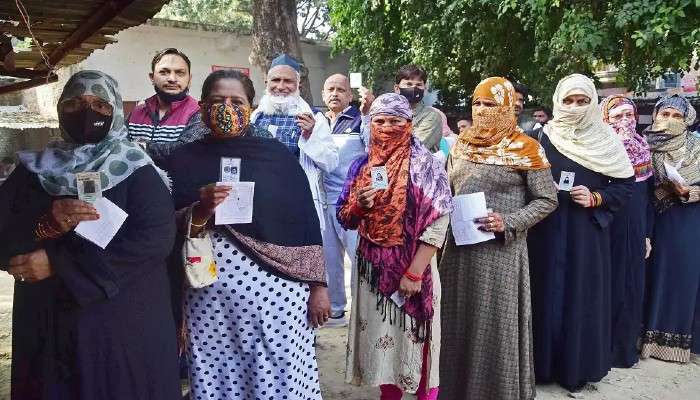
337;137;452;340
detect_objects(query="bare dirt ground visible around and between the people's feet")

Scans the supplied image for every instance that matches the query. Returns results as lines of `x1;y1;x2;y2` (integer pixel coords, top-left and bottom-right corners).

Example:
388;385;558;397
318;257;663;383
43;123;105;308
0;272;700;400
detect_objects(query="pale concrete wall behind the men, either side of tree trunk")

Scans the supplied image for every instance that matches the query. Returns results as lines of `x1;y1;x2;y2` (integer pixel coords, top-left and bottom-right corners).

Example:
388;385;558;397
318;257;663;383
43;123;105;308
80;21;348;106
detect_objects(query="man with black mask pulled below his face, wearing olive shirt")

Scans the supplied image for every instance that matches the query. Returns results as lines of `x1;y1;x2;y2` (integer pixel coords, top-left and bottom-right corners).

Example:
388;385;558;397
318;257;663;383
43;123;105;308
394;64;442;153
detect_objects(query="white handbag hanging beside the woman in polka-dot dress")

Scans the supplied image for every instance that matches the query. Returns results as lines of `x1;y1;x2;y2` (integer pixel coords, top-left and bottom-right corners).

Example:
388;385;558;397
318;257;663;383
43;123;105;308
182;209;219;289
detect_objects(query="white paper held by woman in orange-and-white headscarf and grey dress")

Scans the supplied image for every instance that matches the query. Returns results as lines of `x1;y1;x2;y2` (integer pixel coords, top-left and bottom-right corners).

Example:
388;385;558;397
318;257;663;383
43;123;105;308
450;192;496;246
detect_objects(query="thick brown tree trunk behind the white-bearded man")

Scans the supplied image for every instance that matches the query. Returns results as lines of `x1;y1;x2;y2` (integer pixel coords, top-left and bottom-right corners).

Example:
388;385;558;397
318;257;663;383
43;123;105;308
249;0;313;106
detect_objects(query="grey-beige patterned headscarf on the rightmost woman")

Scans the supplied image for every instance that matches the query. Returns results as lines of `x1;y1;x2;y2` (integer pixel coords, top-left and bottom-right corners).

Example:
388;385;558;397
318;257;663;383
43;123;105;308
644;95;700;211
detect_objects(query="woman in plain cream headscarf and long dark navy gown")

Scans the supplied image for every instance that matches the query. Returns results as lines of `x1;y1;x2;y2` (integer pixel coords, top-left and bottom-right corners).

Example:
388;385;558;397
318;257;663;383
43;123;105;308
528;74;635;392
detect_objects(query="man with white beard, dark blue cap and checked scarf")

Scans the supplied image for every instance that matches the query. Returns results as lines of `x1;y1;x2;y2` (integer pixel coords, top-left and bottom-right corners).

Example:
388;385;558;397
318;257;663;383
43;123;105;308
250;54;338;238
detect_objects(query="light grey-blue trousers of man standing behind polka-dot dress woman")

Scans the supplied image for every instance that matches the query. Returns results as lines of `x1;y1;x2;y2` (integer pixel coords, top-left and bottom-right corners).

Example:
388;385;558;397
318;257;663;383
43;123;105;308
321;204;358;315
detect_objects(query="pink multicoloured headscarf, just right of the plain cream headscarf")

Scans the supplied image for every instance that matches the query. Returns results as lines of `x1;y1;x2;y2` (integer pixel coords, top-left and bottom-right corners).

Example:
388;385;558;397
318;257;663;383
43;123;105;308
600;94;653;182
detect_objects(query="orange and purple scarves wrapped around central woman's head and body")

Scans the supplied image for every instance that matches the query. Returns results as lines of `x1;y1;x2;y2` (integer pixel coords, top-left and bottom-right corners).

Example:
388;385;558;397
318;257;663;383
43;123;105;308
337;93;452;341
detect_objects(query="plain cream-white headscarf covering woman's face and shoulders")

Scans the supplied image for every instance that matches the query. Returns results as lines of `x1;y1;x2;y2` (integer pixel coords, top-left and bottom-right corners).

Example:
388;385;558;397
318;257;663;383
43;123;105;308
543;74;634;178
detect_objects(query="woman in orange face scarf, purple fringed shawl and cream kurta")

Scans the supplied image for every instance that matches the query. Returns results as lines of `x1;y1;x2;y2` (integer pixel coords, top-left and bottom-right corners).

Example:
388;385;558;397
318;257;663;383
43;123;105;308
337;93;452;400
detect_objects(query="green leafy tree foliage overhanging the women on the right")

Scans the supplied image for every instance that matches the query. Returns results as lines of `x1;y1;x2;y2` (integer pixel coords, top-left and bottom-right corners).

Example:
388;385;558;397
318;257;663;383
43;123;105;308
328;0;700;105
